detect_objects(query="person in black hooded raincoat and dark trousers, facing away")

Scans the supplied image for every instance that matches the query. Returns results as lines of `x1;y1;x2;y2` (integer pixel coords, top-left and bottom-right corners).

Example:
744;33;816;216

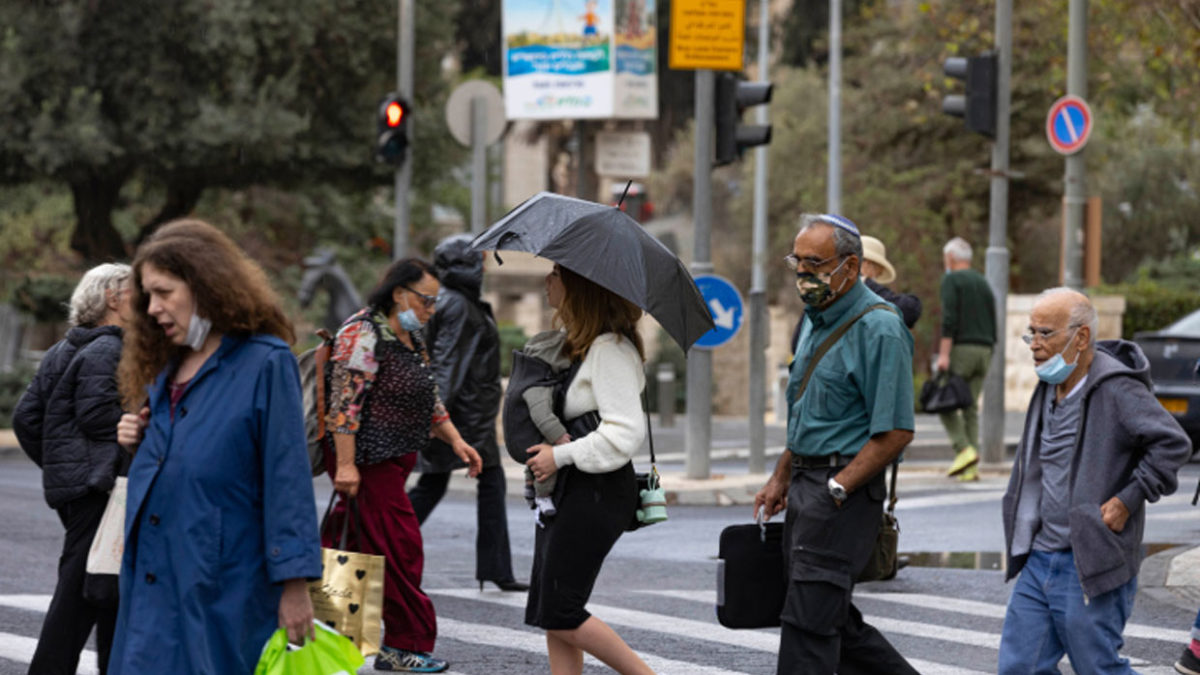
408;234;528;591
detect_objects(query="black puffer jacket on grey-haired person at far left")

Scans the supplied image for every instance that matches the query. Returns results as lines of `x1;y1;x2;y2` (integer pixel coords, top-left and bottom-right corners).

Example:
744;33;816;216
12;325;124;508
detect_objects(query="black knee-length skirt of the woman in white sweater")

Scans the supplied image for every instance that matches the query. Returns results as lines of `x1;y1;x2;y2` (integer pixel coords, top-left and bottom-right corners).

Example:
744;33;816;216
526;462;637;631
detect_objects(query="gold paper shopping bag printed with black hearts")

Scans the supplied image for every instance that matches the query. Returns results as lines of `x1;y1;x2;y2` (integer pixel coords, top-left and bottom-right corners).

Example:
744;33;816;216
308;494;385;656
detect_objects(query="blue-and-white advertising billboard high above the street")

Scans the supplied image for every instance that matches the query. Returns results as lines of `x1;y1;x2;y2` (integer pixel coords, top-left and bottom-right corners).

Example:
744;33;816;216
500;0;658;120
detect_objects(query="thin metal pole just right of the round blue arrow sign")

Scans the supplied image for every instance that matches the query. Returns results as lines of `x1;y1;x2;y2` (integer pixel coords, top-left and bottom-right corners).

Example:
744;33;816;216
749;0;770;473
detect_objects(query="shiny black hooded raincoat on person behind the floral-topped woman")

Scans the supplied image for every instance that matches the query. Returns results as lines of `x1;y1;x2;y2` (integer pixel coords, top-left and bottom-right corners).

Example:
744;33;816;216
418;234;502;473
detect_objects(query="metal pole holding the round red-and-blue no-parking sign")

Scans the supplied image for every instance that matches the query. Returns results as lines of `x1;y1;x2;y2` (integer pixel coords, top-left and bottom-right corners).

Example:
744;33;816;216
1062;0;1087;289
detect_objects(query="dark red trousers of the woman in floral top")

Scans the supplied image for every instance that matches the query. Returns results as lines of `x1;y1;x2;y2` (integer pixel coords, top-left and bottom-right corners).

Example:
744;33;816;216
322;453;438;652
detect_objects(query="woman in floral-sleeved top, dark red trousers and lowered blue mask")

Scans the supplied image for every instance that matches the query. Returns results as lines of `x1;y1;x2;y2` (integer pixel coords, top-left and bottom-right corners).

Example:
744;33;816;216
324;258;481;673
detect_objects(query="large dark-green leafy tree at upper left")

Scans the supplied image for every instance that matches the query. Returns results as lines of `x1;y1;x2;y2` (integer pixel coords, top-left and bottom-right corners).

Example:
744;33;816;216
0;0;461;259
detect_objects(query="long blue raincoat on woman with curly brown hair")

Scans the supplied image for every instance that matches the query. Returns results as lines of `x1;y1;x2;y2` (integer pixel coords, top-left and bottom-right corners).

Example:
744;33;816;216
108;335;322;675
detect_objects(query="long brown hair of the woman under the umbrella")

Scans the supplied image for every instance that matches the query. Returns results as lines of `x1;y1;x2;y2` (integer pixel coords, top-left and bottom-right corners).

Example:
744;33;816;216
554;265;646;362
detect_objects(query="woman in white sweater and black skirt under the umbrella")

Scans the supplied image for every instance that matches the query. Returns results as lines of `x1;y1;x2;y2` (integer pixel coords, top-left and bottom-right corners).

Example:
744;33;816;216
526;264;653;675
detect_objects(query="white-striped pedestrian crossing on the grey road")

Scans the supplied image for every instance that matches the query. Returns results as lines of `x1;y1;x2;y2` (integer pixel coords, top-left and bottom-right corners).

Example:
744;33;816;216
0;585;1189;675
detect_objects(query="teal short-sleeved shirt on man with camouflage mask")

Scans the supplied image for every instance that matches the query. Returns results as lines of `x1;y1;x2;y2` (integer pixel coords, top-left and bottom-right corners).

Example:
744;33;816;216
787;276;914;456
